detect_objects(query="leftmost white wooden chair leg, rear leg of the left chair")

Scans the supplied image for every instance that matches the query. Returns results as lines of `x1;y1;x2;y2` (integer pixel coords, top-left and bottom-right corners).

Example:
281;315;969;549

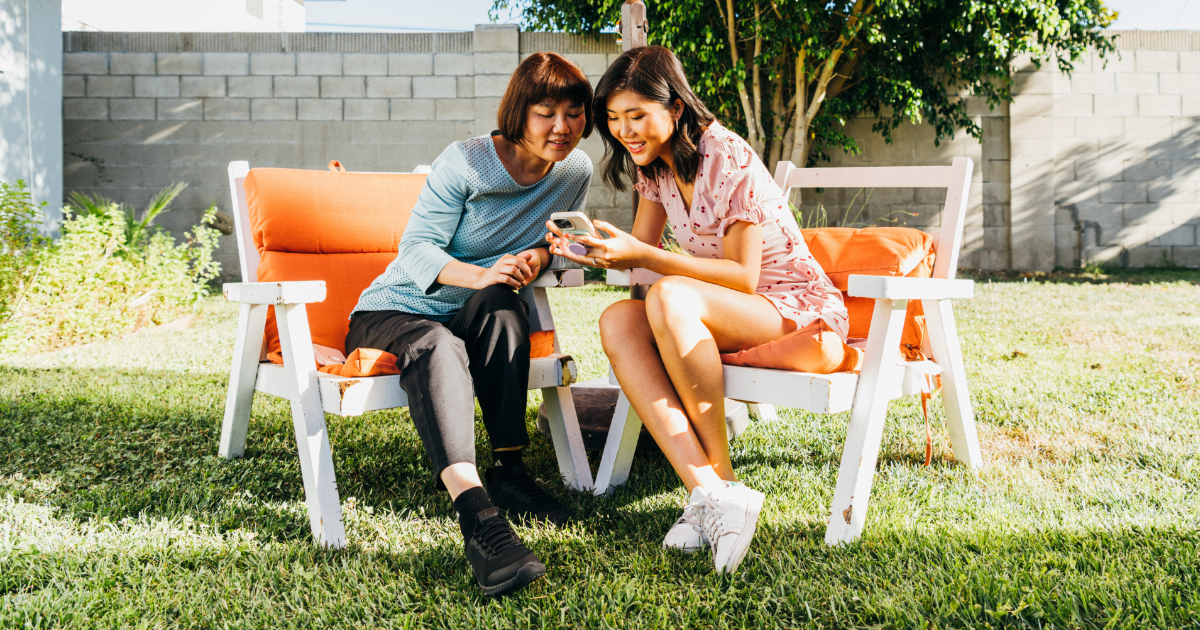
217;304;269;460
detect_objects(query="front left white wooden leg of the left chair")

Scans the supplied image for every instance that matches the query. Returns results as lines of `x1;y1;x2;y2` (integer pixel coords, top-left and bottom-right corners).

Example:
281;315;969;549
275;304;346;548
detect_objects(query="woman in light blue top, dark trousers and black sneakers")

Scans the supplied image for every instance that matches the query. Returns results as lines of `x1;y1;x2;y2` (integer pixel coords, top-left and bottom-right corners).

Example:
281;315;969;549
346;53;592;595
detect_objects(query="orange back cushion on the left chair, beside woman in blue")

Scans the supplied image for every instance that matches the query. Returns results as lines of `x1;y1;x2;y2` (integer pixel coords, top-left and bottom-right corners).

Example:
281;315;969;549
245;168;425;353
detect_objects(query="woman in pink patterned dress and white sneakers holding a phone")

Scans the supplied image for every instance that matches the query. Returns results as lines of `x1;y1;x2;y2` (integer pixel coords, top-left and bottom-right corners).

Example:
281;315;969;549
547;46;847;572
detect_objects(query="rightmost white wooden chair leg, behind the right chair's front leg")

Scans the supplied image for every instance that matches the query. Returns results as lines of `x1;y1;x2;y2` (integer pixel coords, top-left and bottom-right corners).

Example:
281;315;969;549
922;300;983;468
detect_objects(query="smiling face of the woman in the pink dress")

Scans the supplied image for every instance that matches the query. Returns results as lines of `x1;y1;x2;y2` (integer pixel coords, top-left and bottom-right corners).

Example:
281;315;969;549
606;90;683;167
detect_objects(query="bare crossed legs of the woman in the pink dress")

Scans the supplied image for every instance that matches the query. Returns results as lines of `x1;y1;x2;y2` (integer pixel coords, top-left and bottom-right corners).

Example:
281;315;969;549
600;277;791;491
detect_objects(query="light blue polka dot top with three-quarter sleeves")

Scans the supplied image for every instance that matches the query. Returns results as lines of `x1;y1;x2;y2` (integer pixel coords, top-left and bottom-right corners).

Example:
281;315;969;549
354;136;592;322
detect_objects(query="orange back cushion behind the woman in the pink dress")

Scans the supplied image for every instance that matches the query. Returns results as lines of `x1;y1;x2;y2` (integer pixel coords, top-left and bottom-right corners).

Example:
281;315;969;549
800;228;934;359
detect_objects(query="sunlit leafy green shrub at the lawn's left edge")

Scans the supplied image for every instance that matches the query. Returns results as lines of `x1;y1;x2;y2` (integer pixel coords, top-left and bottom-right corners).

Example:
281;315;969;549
0;181;220;353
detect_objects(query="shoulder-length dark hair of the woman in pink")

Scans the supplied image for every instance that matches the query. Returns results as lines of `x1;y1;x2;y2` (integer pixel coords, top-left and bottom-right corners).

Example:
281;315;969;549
592;46;716;191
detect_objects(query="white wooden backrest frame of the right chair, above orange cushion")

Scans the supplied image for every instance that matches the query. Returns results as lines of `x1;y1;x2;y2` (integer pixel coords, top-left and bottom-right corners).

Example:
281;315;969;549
775;157;974;278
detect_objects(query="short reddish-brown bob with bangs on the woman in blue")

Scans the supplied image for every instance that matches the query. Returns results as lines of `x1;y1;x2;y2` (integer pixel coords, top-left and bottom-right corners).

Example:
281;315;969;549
496;53;593;144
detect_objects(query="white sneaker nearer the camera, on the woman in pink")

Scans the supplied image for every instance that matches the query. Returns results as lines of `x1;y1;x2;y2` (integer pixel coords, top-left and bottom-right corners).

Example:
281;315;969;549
698;484;766;574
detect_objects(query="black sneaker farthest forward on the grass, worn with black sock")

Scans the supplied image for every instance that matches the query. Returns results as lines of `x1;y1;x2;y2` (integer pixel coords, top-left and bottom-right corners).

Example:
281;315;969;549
467;508;546;595
